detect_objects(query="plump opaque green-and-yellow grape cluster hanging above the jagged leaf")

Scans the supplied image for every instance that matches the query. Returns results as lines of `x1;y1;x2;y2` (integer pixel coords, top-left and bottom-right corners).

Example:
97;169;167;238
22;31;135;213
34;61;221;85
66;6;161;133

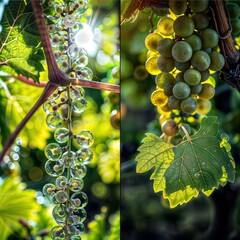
145;0;225;133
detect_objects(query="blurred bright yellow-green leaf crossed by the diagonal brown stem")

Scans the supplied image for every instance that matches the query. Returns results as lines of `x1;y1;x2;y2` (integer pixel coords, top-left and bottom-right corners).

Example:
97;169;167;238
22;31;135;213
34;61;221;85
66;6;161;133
0;79;49;149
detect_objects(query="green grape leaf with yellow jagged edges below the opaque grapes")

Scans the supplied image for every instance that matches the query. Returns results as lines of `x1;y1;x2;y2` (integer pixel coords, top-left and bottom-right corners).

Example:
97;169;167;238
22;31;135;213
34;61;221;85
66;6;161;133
136;117;235;208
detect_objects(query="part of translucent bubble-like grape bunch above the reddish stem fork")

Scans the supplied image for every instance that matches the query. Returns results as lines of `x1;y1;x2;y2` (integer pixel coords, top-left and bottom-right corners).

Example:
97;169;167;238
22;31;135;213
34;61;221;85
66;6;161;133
47;0;93;80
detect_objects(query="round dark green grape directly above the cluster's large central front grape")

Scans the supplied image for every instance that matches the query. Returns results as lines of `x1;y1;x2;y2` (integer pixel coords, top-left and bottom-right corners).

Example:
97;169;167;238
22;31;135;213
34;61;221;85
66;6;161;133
173;15;195;37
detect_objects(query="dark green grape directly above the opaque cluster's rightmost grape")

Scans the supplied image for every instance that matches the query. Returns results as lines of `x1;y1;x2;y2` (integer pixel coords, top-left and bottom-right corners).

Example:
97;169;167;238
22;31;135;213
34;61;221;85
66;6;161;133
200;28;219;48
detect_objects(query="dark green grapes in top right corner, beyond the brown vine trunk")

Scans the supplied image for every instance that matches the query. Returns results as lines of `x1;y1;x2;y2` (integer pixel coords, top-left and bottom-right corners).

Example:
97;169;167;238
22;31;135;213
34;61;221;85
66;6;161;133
227;1;240;35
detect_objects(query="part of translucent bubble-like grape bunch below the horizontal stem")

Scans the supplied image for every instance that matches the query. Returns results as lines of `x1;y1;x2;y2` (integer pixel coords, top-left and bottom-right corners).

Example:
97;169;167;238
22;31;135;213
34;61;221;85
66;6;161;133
43;86;94;239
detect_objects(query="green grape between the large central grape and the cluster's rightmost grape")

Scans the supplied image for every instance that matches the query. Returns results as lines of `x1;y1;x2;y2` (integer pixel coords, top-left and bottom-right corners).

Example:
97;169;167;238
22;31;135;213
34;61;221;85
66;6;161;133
191;51;210;71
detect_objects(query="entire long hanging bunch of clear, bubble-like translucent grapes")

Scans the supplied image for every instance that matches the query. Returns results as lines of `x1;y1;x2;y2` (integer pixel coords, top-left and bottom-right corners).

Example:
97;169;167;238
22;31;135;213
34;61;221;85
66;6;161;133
43;0;94;239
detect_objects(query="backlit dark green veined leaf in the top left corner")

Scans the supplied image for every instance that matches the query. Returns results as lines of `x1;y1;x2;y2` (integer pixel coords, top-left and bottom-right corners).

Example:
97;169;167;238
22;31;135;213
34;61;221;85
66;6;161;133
0;0;44;82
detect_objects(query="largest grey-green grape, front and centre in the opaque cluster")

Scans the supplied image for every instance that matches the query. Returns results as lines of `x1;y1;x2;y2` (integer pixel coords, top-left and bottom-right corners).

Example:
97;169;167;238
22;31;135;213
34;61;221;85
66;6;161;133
172;41;192;62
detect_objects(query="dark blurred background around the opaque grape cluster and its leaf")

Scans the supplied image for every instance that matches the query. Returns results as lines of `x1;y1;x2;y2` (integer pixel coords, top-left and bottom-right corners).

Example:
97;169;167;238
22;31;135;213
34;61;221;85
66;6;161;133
121;1;240;240
